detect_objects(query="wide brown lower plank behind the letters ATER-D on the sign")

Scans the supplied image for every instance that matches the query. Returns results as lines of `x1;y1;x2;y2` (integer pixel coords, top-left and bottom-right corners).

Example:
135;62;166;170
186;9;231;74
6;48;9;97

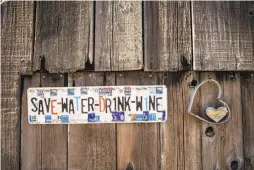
68;72;116;170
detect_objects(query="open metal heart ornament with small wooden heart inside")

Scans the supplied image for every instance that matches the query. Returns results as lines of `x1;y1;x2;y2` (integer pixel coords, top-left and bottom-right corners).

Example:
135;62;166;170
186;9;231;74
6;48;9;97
188;79;231;124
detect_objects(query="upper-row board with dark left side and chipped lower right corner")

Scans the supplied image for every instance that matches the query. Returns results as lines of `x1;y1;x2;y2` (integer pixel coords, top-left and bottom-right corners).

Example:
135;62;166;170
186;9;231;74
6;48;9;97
144;1;192;71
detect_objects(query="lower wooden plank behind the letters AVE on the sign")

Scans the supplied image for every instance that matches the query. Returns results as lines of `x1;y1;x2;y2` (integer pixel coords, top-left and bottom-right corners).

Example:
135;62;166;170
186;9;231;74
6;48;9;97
40;73;68;169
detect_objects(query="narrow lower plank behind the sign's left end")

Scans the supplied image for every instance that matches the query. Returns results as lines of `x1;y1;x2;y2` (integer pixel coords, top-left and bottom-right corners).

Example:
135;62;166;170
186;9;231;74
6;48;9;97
18;73;42;170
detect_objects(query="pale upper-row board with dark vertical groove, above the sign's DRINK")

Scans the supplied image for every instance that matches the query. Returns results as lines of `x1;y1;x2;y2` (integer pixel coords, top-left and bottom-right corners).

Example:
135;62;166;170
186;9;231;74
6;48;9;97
94;1;143;71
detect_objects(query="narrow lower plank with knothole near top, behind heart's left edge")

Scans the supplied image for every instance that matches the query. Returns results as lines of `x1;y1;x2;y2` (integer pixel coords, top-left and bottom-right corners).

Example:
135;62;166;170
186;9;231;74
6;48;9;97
184;72;202;170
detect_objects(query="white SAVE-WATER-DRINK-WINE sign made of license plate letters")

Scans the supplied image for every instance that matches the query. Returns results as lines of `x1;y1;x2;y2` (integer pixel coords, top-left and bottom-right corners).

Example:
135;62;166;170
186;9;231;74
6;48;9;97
27;85;167;124
